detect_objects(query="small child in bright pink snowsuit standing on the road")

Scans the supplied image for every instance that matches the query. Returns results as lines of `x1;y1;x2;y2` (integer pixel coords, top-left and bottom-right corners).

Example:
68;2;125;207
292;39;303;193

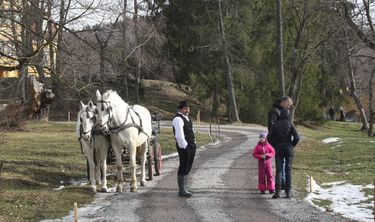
253;132;275;194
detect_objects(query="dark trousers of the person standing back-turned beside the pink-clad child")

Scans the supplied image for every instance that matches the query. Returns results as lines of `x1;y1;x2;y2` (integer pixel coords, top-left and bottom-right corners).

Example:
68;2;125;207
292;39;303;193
275;145;293;192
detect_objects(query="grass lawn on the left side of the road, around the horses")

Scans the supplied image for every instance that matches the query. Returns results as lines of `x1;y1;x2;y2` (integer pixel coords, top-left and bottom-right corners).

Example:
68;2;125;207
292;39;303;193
0;121;210;221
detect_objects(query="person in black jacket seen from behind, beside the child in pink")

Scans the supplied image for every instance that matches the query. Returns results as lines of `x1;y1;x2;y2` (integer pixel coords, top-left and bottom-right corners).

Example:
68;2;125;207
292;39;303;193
268;109;299;198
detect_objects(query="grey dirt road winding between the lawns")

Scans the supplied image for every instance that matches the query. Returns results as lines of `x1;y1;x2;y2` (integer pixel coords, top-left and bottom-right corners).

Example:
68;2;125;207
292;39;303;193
46;126;345;222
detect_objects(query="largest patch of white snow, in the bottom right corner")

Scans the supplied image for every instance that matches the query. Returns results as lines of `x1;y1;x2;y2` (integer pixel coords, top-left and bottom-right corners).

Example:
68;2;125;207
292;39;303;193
305;181;374;222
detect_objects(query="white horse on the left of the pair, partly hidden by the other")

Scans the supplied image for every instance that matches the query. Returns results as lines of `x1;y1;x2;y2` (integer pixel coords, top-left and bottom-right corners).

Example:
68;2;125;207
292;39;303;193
76;101;109;192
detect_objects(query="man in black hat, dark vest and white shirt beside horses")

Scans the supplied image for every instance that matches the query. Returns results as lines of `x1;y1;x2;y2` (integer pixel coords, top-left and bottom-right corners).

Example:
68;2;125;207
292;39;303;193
172;101;196;197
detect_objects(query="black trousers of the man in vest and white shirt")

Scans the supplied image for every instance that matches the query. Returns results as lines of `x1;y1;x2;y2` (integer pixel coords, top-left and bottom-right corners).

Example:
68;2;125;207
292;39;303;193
177;145;196;176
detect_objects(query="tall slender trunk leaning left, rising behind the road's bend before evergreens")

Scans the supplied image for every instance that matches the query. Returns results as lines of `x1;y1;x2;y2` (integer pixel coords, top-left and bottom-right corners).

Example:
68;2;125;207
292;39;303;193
218;0;240;122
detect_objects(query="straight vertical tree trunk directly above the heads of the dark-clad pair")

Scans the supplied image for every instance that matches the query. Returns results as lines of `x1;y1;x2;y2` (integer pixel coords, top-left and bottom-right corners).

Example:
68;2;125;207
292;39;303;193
276;0;285;96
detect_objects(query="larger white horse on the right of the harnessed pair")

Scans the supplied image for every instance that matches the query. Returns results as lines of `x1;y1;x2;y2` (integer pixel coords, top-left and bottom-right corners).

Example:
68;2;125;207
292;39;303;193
96;90;152;192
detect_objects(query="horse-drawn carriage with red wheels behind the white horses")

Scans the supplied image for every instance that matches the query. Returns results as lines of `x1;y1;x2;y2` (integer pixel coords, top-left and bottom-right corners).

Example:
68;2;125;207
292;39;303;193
107;115;162;180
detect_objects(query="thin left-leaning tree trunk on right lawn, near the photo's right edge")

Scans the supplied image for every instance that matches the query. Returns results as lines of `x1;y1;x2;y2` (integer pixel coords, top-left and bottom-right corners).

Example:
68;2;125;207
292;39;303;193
344;30;368;130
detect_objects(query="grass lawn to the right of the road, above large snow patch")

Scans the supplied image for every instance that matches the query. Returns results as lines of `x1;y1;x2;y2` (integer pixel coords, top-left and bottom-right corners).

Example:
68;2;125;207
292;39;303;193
293;121;375;197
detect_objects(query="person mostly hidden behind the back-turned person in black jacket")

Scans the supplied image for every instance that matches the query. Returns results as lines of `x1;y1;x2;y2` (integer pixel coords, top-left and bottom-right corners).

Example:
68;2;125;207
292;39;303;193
267;96;293;190
